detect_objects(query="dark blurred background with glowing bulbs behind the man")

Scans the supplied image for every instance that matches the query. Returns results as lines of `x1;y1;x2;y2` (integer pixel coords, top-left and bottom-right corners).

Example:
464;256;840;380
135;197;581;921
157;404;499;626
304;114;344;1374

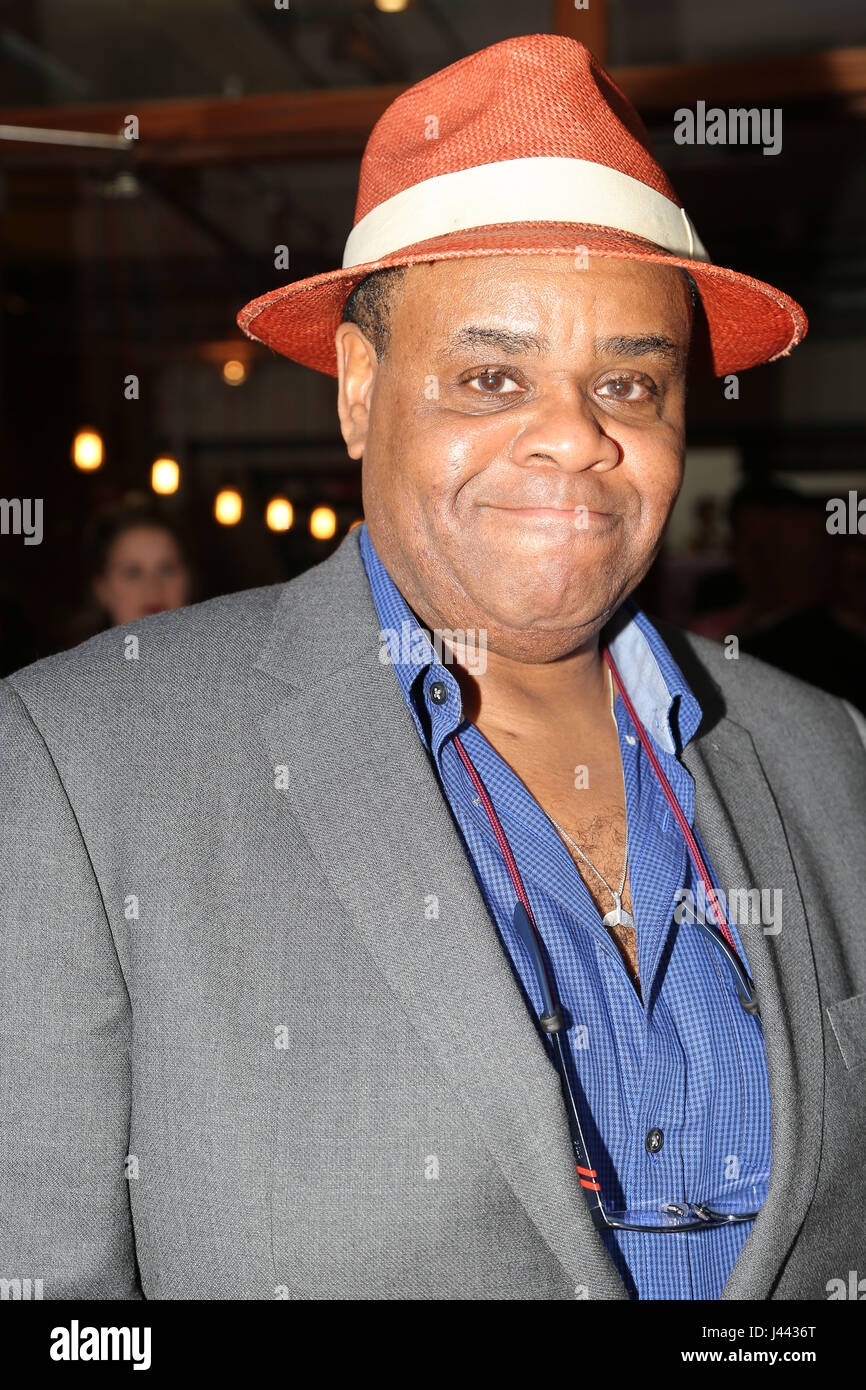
0;0;866;708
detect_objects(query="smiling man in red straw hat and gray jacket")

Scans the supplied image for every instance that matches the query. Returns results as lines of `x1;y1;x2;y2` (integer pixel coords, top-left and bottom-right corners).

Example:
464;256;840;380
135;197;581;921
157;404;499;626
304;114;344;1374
0;35;866;1300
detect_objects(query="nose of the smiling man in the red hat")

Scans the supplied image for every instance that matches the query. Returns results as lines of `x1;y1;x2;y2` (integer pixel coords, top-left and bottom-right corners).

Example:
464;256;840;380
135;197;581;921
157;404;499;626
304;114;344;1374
512;385;623;473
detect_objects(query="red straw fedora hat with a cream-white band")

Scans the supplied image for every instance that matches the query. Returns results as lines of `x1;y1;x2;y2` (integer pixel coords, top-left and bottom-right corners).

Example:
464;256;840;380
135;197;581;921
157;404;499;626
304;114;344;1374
238;33;806;377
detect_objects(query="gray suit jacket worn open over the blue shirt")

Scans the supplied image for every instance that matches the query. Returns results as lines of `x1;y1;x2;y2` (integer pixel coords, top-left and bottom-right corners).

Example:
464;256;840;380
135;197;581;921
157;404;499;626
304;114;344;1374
0;532;866;1300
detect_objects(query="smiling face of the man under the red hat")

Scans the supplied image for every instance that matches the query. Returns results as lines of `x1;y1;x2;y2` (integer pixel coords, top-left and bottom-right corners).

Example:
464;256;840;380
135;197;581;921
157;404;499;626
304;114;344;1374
338;256;691;660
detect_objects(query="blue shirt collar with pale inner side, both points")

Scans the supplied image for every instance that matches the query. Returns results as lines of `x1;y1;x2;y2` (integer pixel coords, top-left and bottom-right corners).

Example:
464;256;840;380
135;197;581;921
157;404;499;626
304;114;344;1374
359;523;702;756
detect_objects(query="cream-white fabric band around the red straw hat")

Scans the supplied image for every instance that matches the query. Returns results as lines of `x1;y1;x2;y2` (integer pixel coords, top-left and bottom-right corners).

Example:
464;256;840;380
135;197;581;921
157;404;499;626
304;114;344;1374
343;156;709;270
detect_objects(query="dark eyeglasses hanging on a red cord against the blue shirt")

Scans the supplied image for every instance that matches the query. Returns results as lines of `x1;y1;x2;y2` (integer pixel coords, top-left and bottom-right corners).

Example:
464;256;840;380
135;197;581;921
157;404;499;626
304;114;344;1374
453;639;769;1232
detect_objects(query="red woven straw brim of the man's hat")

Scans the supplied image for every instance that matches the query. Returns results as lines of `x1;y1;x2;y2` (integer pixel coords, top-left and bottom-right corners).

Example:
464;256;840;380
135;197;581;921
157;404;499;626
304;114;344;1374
238;222;808;377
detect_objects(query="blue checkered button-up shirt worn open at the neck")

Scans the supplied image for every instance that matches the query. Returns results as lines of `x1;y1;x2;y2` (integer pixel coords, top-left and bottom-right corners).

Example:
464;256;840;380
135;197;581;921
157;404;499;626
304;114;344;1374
360;525;770;1298
